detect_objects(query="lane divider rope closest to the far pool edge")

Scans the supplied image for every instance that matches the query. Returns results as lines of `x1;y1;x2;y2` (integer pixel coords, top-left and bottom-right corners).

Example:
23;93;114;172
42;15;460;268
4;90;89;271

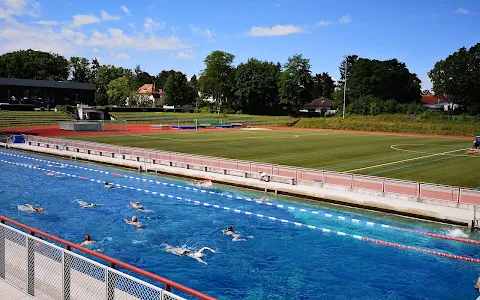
0;151;480;245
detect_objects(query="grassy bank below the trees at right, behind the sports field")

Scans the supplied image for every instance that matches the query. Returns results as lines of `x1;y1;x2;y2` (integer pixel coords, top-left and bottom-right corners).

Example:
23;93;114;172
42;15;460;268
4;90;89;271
294;115;480;136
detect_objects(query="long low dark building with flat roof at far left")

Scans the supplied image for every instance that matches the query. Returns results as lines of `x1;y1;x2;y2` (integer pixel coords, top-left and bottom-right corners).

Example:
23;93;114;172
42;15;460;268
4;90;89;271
0;77;96;108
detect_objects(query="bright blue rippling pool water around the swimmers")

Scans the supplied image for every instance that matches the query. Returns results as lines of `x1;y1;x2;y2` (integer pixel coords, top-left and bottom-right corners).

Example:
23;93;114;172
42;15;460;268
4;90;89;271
0;151;480;299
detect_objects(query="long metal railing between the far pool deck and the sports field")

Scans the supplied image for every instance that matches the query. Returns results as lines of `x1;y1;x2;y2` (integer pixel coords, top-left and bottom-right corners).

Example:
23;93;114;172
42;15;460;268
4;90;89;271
25;135;480;204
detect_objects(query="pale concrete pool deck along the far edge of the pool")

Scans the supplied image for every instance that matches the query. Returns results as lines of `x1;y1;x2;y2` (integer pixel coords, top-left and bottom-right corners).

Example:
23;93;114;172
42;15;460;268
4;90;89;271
0;143;474;227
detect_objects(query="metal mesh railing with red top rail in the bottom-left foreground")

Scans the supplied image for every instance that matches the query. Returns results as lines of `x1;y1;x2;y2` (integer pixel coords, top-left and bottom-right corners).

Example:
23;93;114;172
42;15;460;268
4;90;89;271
0;215;215;300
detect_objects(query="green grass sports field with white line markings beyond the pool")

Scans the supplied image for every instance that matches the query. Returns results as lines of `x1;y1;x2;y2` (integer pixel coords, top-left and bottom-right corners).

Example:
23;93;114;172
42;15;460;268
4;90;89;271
68;130;480;188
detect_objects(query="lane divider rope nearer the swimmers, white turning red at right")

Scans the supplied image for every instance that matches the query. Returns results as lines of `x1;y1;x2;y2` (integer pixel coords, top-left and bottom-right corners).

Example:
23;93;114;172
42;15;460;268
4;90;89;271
0;159;480;263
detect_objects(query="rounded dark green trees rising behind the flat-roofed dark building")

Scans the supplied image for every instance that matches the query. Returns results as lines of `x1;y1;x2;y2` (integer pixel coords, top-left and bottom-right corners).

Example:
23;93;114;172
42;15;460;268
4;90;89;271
0;49;69;81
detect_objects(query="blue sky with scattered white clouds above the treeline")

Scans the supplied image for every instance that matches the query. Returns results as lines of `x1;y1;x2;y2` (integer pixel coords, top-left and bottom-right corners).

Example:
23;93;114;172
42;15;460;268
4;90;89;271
0;0;480;88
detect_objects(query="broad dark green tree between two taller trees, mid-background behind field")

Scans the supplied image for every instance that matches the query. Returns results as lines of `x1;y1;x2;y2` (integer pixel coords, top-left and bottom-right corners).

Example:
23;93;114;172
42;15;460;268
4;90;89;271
235;58;279;114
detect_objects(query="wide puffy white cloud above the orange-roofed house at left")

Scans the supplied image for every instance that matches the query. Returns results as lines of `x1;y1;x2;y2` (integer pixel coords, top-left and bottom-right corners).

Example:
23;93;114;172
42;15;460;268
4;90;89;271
85;28;189;51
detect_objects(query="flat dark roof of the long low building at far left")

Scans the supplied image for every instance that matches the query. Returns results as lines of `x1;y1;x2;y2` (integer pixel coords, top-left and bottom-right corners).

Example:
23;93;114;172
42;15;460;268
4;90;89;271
0;77;97;91
